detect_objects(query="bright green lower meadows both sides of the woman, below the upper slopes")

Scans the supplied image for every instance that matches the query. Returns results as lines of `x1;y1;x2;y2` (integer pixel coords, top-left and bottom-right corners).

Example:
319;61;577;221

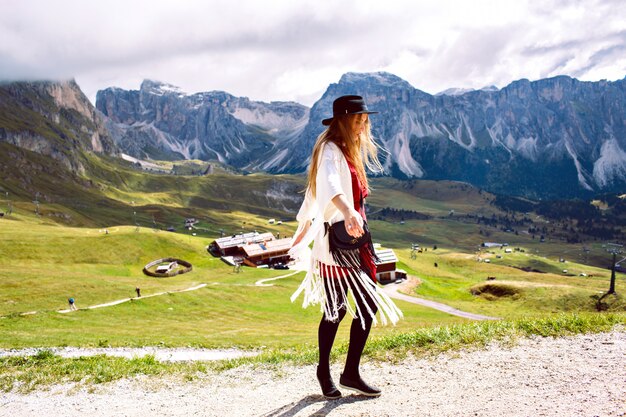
0;211;623;348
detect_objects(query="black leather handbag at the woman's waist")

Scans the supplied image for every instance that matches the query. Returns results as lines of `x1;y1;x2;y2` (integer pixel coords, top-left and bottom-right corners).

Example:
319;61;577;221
324;220;378;269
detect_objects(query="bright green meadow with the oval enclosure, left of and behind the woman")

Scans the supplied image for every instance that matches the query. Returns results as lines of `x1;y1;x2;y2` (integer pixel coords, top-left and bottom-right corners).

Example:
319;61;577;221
0;221;465;347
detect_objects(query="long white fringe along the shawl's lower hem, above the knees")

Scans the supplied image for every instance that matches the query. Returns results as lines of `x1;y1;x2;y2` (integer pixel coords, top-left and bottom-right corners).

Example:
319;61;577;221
291;260;403;329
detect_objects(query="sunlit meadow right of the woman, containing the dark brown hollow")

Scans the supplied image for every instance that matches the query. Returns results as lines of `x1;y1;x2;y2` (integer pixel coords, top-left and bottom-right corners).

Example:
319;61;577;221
392;249;624;318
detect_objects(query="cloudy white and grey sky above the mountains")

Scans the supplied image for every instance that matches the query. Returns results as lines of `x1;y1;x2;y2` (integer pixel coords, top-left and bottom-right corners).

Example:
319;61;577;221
0;0;626;106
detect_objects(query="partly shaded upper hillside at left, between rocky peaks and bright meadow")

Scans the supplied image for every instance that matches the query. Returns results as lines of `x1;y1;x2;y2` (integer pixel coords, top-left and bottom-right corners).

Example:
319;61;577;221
0;143;302;236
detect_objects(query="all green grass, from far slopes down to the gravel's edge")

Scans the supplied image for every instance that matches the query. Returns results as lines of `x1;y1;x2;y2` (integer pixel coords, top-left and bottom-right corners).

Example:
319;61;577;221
0;161;626;392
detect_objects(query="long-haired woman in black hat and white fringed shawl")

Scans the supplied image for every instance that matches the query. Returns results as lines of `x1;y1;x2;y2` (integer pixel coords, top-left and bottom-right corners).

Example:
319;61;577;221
290;96;402;399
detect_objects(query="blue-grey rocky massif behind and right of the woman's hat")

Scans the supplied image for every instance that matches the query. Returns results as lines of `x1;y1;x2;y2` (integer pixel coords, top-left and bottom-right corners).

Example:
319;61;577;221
303;73;626;198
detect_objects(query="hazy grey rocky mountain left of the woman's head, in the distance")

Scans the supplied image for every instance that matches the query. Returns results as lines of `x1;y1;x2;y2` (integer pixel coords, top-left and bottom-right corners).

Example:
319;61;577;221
96;80;309;170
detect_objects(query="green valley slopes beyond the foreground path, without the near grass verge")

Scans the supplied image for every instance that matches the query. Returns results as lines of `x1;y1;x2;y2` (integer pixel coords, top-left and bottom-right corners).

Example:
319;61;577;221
0;144;626;348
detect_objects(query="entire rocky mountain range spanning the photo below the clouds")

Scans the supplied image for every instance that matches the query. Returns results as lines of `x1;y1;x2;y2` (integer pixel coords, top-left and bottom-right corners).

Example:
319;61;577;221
0;72;626;199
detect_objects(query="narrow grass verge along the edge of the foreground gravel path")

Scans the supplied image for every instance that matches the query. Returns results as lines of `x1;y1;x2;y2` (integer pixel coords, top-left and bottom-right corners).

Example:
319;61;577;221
0;313;626;392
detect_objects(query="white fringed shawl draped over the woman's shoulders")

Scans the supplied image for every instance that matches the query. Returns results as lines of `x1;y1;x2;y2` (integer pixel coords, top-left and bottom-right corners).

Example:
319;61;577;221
289;142;402;328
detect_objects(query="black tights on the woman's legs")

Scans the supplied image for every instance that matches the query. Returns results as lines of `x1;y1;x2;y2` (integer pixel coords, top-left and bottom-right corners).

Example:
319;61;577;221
317;279;378;378
